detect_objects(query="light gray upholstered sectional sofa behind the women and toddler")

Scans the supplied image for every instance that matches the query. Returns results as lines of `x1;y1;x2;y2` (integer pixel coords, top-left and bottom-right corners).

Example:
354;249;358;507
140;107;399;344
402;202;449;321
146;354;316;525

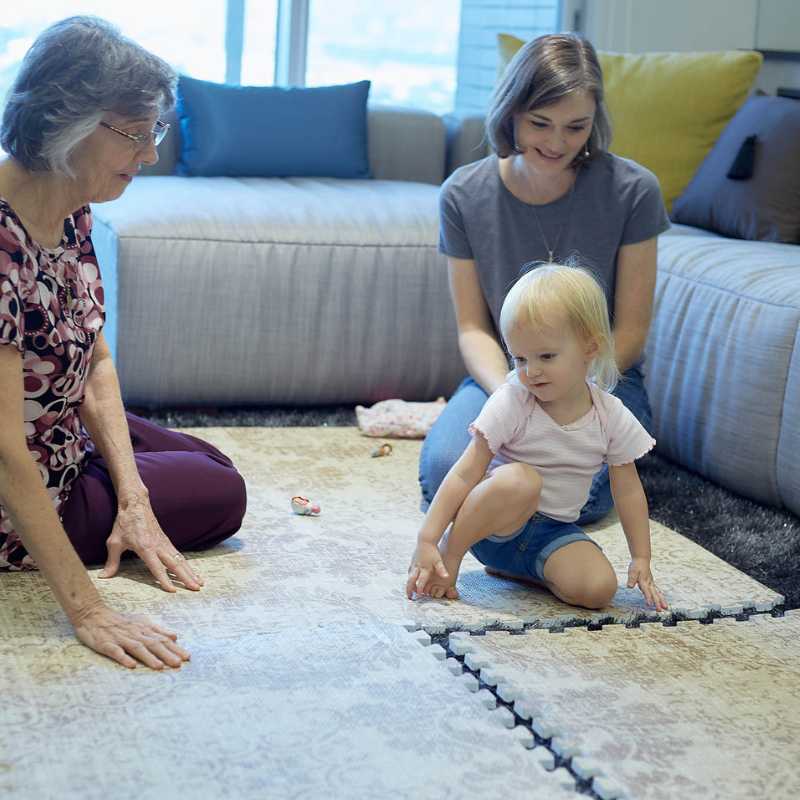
94;108;800;513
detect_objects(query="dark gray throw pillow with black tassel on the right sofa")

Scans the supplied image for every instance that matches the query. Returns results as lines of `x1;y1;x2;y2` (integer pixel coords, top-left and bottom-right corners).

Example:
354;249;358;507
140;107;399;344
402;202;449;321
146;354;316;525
672;95;800;244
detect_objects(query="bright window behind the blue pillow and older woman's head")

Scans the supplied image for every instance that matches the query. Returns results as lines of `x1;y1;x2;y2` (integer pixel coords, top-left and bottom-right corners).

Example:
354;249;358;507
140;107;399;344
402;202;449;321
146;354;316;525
0;0;462;112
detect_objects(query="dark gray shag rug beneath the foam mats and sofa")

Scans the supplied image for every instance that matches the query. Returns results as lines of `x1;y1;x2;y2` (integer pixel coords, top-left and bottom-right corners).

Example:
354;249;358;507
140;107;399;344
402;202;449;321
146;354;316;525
130;406;800;609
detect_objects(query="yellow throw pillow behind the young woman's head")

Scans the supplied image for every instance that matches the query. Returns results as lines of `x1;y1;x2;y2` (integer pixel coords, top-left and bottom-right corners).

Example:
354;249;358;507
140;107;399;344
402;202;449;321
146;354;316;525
498;33;763;210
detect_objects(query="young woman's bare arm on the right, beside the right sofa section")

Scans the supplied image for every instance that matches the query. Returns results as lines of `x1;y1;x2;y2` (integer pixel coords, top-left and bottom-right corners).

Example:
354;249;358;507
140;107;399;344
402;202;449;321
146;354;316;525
614;237;657;372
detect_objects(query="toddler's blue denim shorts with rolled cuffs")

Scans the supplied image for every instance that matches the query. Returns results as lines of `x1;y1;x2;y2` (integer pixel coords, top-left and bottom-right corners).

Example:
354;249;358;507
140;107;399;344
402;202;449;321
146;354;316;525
470;512;603;581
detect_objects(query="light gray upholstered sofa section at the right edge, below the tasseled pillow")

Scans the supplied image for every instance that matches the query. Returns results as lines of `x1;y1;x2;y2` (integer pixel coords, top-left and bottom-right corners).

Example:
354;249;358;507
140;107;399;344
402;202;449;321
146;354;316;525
646;235;800;513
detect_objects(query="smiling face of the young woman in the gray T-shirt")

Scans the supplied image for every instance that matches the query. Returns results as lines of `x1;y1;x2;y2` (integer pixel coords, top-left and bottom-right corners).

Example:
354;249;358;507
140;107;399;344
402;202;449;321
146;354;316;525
514;92;596;173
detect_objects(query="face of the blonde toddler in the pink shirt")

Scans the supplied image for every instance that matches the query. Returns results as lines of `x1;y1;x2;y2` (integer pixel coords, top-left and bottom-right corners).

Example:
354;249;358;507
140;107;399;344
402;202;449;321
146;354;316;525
506;318;596;404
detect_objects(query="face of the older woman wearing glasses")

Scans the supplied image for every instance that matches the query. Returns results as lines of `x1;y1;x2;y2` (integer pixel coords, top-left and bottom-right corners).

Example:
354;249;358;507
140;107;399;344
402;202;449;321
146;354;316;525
72;113;158;203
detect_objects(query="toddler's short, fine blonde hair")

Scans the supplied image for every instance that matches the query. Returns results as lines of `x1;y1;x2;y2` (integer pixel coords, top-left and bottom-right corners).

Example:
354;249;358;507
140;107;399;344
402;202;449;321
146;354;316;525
500;264;620;392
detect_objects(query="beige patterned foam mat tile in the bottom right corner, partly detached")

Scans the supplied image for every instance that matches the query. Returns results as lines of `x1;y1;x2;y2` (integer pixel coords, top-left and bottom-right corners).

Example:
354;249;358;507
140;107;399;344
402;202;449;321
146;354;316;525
450;611;800;800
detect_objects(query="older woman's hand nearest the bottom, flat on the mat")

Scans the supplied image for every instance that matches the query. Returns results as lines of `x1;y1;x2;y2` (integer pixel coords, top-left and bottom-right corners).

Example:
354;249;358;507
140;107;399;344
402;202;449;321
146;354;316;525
72;603;190;669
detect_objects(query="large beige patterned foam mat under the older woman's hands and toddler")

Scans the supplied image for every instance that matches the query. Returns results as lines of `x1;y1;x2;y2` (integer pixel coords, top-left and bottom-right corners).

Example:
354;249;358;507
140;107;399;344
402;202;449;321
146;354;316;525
0;428;782;800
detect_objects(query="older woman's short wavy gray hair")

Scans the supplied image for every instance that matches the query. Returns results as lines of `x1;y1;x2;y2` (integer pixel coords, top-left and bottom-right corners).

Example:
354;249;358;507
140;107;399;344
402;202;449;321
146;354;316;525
0;17;177;177
